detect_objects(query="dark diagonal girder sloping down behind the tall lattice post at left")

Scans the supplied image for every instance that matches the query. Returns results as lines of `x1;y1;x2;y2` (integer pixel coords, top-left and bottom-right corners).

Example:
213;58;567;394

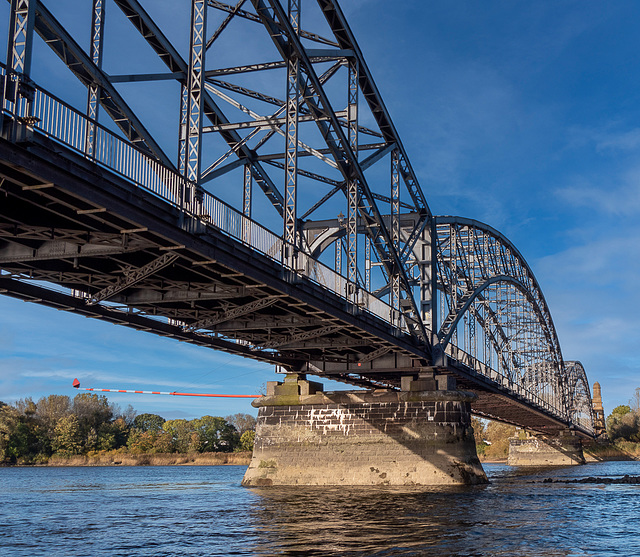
114;0;284;216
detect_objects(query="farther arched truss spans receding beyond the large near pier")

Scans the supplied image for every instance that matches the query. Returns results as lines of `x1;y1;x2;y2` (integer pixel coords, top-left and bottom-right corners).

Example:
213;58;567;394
434;217;593;431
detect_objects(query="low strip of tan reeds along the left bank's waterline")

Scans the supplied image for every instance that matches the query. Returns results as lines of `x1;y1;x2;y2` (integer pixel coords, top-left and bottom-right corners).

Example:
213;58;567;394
7;451;251;466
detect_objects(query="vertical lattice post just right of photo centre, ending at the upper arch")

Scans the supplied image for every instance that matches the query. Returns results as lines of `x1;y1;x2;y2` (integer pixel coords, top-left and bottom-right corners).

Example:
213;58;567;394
347;58;360;296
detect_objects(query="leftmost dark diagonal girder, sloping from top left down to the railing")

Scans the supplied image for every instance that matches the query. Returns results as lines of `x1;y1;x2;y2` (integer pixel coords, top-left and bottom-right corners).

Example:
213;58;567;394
29;2;175;165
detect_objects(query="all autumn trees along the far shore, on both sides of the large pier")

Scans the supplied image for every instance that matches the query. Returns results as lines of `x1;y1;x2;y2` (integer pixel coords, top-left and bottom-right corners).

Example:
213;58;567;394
5;388;640;466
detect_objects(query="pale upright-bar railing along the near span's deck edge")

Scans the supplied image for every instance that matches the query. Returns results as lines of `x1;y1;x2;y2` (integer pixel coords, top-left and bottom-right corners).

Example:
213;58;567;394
0;70;403;325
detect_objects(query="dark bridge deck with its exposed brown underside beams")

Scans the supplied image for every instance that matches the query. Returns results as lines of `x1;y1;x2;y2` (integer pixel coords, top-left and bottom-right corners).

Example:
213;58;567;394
0;133;587;434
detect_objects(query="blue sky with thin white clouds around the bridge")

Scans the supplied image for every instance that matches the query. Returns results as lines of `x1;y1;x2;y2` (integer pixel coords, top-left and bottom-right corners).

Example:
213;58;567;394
0;0;640;417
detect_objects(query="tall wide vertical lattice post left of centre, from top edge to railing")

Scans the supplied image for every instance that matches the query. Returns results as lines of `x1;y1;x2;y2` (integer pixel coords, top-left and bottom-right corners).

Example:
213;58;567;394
186;0;207;184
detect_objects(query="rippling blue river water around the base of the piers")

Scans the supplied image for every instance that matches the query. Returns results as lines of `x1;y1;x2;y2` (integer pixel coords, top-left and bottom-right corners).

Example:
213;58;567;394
0;462;640;557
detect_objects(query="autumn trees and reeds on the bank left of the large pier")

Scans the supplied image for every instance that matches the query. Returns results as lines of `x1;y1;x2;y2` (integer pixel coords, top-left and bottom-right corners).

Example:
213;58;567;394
0;393;256;466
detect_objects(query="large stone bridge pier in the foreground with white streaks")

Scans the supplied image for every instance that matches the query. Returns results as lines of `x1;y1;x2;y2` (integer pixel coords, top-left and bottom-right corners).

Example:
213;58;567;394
242;373;487;486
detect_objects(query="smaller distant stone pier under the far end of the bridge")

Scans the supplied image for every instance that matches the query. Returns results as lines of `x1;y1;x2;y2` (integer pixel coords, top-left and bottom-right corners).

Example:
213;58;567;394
507;430;585;466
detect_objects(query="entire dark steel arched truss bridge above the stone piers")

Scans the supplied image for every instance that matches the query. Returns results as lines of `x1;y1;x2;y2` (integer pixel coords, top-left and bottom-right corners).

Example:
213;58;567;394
0;0;593;436
